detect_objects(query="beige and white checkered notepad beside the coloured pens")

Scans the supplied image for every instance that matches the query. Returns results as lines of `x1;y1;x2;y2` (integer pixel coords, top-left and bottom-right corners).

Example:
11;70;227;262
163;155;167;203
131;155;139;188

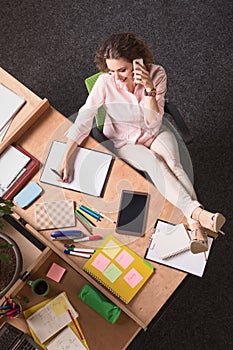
34;200;75;230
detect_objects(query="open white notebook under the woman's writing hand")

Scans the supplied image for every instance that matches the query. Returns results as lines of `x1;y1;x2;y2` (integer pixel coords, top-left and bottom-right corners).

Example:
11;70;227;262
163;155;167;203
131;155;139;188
40;141;113;197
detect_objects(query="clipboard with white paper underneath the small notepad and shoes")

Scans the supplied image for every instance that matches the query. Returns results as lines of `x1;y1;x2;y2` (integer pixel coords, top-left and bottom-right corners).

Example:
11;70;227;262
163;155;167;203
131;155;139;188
144;220;213;277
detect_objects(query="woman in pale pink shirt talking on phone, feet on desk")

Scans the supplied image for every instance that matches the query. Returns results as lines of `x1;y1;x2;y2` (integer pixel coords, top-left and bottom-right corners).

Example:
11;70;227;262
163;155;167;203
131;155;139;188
60;33;225;253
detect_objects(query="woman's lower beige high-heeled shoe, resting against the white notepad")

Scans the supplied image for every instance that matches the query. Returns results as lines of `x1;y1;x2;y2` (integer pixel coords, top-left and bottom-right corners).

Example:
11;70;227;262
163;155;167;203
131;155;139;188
188;219;208;254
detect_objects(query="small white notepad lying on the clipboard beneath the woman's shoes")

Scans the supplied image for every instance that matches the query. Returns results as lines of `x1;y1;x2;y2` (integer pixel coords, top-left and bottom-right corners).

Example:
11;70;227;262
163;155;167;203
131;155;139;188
154;223;190;259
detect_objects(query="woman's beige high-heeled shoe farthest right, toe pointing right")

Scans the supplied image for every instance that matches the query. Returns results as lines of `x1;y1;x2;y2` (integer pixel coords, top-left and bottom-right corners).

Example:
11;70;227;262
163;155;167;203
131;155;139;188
192;207;226;233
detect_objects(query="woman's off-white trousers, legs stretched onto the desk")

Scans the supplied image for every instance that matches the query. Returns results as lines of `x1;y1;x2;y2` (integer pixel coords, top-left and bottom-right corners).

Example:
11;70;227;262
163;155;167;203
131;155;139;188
117;125;201;219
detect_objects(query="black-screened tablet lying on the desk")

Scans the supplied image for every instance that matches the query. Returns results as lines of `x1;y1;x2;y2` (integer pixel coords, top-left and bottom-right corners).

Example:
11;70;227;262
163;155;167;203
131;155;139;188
116;190;149;237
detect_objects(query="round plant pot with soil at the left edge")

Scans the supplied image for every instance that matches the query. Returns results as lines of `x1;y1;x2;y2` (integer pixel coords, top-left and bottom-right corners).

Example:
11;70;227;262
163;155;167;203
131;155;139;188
0;232;22;298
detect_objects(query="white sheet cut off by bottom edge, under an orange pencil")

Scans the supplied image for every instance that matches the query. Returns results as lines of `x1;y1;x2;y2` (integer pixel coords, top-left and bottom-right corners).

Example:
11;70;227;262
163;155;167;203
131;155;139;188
46;327;86;350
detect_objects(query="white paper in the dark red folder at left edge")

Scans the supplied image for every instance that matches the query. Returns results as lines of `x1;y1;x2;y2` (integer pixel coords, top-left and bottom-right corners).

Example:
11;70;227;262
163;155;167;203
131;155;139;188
0;146;30;189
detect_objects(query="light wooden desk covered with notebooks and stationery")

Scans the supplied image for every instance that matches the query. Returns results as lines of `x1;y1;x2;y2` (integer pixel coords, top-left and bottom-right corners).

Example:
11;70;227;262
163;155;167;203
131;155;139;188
0;70;187;349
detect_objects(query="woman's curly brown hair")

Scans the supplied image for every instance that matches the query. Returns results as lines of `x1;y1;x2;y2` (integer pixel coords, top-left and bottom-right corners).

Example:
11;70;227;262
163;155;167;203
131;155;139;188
94;32;153;72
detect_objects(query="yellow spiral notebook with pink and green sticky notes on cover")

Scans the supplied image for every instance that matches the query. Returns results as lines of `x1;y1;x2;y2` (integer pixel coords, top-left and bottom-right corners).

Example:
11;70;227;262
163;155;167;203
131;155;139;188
83;235;154;304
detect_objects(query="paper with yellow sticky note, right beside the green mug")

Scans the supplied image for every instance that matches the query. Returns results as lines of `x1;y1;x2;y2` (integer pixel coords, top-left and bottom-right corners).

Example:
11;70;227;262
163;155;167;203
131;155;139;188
27;293;78;343
